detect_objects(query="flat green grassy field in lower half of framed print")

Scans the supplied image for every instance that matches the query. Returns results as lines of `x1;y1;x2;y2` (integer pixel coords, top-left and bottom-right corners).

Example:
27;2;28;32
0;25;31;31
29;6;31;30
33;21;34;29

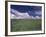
11;19;41;32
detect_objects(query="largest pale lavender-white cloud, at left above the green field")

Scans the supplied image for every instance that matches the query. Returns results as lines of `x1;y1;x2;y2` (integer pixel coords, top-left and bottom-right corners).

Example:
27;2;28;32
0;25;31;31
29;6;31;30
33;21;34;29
11;9;31;19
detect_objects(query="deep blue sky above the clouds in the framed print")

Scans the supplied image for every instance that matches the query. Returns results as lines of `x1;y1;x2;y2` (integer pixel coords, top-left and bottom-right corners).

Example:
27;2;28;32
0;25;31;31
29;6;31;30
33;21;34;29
11;5;42;16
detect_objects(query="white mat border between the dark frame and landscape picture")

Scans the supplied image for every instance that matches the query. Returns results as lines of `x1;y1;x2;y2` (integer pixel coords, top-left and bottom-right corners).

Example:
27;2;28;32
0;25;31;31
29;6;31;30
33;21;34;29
8;2;44;35
